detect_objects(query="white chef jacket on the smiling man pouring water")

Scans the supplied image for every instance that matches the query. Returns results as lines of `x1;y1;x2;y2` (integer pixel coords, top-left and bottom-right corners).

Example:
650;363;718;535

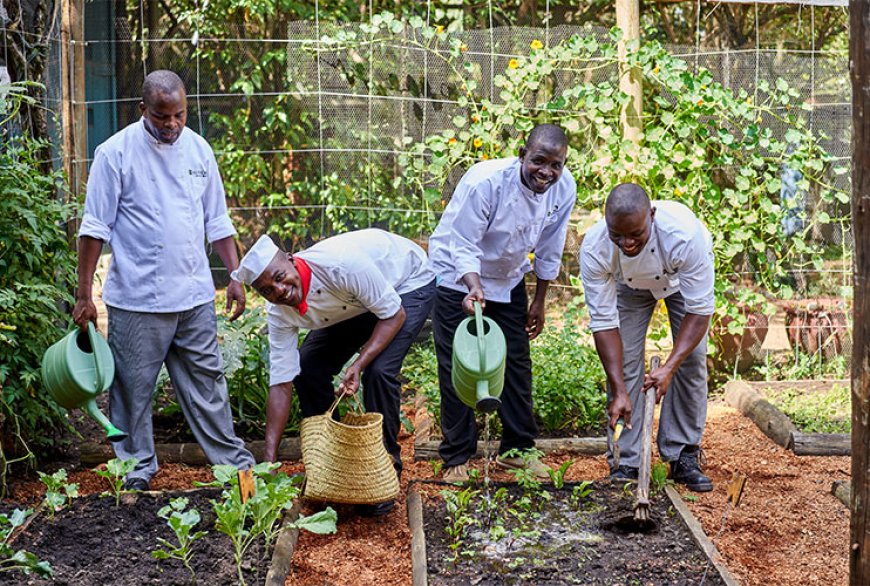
429;157;577;303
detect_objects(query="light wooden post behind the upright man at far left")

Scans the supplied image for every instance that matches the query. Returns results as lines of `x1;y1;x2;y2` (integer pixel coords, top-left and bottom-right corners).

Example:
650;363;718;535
60;0;88;212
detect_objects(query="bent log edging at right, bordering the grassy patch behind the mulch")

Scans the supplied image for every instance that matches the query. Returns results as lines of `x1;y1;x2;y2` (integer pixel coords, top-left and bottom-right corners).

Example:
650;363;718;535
725;380;852;456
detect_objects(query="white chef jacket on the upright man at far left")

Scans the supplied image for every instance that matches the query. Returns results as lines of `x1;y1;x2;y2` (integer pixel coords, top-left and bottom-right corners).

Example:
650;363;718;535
79;119;236;313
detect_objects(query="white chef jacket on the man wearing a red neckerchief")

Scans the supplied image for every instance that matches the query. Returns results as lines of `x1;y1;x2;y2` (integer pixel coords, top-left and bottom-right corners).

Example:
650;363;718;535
266;229;435;385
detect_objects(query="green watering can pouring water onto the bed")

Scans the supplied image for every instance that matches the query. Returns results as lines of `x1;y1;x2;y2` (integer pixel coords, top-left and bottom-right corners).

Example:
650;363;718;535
451;301;507;413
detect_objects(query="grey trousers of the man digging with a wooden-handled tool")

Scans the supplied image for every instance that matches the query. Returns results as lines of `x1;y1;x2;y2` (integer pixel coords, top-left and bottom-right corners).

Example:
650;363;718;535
607;284;707;468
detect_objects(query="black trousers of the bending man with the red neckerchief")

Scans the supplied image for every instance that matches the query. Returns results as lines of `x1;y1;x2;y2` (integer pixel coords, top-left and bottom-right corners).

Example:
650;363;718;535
293;280;435;472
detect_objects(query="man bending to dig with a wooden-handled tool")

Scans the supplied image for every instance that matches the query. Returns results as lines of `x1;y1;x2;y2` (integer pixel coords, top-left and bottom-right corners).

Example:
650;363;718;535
580;183;714;492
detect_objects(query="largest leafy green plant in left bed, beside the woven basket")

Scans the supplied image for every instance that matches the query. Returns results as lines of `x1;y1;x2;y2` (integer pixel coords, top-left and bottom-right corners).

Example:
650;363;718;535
201;462;337;586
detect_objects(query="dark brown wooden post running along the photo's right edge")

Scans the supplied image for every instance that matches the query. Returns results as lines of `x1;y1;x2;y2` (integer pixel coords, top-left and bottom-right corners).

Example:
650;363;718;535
849;0;870;586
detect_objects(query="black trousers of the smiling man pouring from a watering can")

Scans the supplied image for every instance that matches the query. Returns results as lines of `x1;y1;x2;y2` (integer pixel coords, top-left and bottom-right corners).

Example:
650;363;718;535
432;282;538;466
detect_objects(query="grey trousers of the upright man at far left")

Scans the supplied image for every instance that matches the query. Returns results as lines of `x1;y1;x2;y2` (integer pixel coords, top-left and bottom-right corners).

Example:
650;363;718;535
108;303;254;480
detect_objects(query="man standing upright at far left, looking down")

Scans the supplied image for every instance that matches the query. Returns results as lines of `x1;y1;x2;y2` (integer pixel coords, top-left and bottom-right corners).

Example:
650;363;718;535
73;70;254;490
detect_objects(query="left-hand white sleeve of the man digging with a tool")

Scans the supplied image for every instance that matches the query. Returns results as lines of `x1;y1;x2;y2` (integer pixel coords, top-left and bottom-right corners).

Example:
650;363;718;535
580;234;619;332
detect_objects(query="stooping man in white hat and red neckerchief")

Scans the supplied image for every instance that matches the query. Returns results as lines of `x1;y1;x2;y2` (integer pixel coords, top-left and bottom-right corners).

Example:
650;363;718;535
233;229;435;515
